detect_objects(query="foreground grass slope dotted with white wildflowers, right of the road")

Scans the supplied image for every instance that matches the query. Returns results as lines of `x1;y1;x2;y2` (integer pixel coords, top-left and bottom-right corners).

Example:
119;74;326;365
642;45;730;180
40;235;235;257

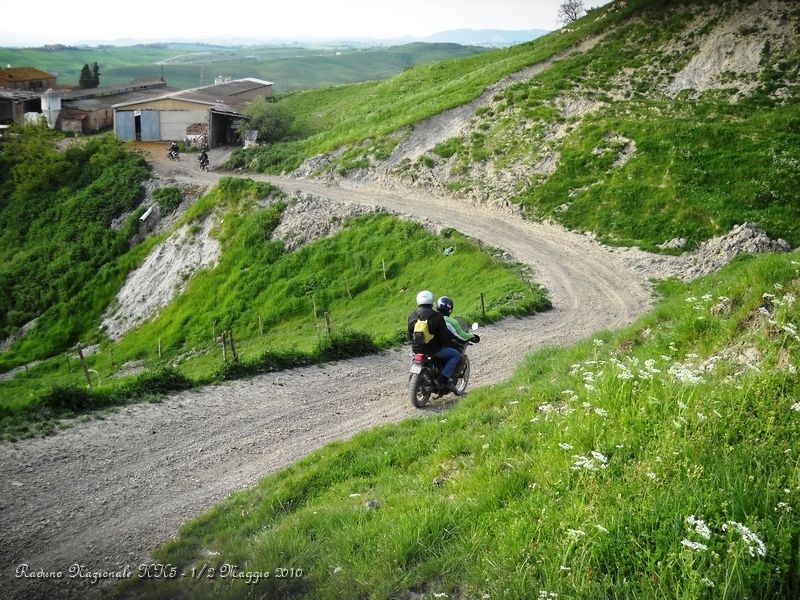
122;253;800;600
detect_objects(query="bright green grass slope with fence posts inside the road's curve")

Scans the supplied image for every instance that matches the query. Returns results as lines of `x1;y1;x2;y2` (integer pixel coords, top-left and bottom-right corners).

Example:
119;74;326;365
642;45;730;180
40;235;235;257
0;178;549;438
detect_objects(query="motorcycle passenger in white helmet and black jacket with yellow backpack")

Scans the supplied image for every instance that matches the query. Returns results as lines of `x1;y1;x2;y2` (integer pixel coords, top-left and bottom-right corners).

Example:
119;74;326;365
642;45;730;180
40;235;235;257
408;290;461;395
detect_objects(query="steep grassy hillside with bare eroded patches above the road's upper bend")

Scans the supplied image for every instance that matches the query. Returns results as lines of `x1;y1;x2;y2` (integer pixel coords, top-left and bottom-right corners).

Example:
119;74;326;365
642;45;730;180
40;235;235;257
233;0;800;249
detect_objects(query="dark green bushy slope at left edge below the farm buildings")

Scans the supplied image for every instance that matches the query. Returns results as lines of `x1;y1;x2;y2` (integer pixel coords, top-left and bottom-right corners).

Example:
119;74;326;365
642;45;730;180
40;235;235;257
0;127;150;356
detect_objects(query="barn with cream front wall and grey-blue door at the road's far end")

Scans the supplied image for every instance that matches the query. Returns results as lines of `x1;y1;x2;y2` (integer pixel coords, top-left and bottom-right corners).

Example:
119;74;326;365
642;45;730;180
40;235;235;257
114;77;272;148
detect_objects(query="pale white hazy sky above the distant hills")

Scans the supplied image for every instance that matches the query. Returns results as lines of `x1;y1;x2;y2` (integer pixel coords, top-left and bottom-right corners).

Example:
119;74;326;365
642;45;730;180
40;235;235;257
0;0;610;45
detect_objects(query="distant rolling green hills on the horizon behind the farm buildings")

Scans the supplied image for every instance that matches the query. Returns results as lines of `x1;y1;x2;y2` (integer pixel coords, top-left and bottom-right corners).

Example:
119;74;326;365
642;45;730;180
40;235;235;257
0;43;486;93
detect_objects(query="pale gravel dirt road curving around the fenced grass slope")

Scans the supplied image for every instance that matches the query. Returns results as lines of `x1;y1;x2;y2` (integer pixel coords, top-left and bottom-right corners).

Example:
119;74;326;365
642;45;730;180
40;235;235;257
0;162;650;599
